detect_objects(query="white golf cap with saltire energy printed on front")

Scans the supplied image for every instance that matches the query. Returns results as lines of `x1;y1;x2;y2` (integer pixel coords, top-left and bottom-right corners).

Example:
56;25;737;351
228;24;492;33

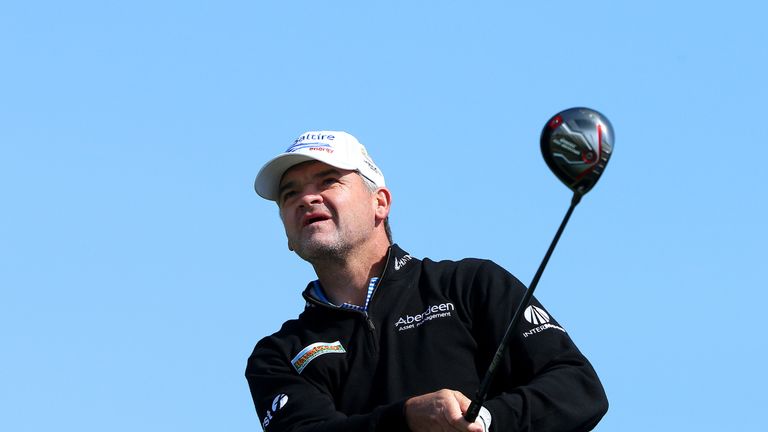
254;131;385;201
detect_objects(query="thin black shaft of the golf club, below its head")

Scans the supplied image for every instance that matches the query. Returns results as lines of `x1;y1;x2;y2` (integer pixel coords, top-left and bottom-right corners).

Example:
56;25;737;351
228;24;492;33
464;192;582;423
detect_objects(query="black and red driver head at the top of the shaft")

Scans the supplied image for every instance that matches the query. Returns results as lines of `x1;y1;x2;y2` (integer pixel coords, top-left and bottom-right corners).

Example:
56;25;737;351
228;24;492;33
541;108;614;196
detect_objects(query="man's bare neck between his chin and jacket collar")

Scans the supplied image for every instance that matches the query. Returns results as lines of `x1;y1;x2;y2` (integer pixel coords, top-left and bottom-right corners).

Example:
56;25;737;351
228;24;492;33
312;238;389;306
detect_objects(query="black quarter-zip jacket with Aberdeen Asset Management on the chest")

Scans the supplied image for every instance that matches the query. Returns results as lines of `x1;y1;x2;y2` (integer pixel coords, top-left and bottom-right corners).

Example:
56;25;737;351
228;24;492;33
245;246;608;432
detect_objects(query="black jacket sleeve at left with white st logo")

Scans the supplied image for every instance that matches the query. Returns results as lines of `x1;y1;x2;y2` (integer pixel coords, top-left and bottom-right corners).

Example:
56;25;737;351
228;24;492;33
245;338;408;432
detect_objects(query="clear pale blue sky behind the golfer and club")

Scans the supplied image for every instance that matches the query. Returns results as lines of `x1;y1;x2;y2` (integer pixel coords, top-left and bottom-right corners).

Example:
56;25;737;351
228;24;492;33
0;1;768;431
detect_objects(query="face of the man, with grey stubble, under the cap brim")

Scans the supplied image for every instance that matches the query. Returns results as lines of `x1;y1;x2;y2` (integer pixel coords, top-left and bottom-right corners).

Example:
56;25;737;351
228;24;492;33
277;161;381;262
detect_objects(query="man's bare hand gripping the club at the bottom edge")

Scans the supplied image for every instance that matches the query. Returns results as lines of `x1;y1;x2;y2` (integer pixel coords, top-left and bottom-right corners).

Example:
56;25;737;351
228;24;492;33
405;389;483;432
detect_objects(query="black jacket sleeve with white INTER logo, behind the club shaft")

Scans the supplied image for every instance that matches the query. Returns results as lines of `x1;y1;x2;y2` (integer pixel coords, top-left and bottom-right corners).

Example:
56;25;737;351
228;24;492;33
469;261;608;431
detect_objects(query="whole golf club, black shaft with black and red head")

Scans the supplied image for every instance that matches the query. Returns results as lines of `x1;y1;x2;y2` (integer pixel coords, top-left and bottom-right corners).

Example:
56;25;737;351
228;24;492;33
464;108;614;423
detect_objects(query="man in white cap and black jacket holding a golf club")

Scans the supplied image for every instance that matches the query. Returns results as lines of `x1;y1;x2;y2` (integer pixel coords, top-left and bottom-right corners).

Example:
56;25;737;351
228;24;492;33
246;131;608;432
